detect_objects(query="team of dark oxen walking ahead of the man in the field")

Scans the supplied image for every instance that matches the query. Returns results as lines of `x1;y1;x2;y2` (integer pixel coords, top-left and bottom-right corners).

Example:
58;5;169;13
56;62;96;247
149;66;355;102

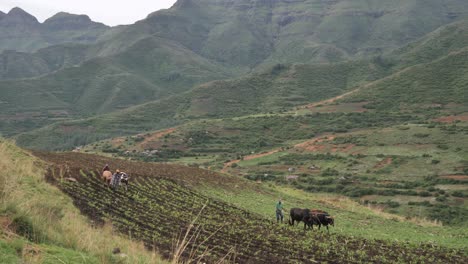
288;208;335;231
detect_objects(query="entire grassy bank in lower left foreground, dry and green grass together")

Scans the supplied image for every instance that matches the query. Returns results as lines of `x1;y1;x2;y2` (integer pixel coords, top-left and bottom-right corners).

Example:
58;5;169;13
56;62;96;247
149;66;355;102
0;139;164;263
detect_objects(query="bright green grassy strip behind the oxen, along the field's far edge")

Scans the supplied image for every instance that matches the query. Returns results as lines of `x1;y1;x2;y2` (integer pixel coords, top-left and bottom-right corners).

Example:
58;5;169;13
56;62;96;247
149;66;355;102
198;186;468;248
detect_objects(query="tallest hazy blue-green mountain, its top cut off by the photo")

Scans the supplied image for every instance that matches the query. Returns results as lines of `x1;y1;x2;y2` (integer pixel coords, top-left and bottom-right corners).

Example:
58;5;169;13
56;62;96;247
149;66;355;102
117;0;468;67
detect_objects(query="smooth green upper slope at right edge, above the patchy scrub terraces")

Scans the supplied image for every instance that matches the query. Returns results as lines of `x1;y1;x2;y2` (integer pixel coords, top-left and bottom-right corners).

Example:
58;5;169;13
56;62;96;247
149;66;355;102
344;49;468;111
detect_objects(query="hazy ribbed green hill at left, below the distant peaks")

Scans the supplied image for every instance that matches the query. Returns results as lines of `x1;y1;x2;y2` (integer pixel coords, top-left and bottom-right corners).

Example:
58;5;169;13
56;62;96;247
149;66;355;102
0;37;230;135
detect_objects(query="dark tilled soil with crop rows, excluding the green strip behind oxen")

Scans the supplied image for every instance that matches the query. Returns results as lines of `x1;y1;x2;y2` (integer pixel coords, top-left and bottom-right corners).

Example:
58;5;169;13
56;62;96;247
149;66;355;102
36;153;468;263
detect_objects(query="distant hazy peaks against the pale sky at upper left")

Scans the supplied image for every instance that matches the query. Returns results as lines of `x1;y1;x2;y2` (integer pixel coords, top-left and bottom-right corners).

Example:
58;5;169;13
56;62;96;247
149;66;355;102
0;7;109;52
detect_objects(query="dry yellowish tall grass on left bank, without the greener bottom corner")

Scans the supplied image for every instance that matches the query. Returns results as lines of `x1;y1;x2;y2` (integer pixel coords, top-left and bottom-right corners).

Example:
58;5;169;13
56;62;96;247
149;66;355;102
0;139;164;263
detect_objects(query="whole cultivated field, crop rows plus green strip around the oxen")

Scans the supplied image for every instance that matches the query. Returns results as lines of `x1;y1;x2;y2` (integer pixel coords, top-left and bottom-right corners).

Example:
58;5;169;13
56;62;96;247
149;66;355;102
29;150;465;263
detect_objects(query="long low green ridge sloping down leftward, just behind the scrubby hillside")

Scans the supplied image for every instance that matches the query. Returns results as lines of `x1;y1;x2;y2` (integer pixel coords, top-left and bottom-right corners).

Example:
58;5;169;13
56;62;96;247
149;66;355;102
12;61;385;149
